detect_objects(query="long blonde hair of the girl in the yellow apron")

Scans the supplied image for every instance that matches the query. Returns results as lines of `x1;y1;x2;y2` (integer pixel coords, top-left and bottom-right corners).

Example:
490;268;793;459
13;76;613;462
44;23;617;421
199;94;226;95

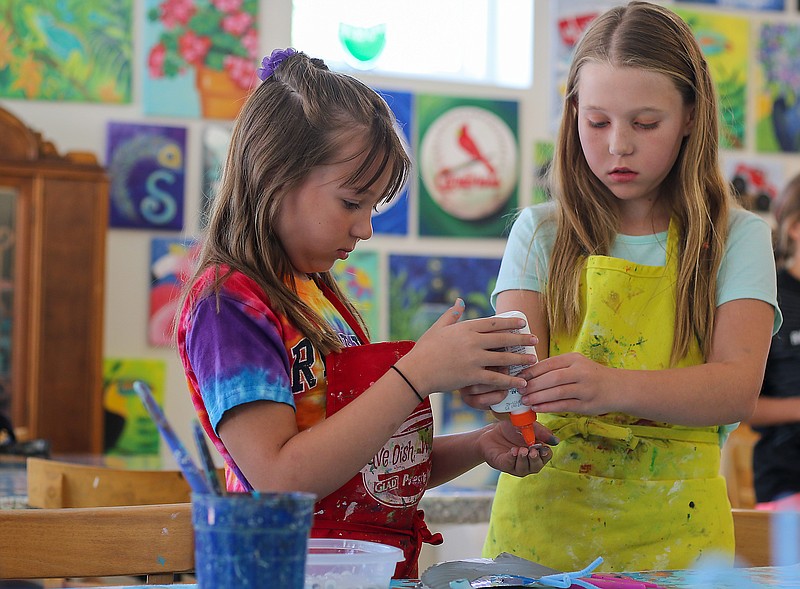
545;1;732;365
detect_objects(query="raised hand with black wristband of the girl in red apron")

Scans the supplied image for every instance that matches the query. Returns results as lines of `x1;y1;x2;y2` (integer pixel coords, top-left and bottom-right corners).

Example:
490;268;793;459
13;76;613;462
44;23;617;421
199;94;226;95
397;299;538;395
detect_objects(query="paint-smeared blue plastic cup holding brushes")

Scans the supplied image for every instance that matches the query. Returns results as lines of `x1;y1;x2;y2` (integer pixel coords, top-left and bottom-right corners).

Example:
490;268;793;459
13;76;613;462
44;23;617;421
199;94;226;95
192;493;316;589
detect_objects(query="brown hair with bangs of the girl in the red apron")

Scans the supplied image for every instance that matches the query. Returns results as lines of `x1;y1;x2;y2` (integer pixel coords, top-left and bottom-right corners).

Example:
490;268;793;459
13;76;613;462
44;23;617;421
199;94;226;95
179;52;411;355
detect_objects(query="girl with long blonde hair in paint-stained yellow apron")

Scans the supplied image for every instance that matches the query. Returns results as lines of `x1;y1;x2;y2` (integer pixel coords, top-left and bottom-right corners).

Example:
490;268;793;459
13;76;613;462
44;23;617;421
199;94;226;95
462;2;780;571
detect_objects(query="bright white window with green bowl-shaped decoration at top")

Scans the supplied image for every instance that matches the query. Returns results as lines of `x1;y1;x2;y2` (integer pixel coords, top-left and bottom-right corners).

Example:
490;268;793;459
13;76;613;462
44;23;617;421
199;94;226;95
292;0;533;88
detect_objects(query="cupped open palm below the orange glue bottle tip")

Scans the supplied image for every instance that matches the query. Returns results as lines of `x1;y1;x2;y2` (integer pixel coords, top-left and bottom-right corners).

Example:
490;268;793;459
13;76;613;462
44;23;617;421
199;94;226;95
478;420;558;477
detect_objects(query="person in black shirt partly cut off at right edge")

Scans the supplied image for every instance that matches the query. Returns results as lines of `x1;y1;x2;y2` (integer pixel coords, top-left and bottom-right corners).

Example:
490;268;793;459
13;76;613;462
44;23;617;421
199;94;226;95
749;175;800;510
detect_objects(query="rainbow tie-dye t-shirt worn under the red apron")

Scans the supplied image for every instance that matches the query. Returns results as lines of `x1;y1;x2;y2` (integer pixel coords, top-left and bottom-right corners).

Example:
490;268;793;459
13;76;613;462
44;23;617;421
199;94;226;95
178;269;362;491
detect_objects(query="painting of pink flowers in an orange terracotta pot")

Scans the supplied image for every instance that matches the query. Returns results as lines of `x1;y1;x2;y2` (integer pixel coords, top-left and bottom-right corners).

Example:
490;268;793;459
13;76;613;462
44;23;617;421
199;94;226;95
143;0;260;120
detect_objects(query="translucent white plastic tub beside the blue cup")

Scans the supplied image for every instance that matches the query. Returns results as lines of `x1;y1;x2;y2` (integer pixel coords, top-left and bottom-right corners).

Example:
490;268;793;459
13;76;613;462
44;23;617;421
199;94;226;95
305;538;403;589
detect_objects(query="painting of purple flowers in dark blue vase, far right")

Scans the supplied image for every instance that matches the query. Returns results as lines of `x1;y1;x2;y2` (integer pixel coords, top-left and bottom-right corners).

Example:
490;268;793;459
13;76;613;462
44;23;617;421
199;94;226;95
756;22;800;153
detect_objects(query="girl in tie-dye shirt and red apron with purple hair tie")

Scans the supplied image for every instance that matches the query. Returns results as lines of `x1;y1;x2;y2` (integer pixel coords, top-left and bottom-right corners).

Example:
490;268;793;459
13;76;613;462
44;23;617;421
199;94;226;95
177;49;553;577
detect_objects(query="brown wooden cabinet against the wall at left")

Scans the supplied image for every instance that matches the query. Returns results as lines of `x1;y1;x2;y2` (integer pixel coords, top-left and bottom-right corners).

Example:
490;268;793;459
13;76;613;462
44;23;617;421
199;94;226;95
0;108;108;453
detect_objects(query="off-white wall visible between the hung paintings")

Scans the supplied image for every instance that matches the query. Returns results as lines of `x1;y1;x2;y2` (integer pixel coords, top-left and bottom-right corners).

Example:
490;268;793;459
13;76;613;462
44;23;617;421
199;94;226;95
0;0;800;460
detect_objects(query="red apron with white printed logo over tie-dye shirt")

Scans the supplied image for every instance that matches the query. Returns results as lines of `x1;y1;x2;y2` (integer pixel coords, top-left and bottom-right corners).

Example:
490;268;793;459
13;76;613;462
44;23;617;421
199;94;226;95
311;289;442;579
